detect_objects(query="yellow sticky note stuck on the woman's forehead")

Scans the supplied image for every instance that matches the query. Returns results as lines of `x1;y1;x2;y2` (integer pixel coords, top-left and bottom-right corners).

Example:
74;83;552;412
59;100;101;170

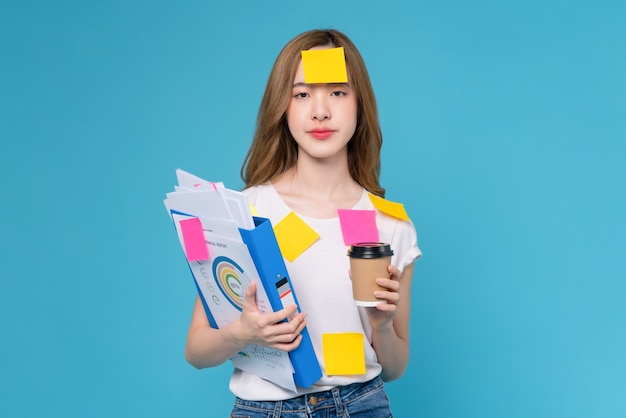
302;47;348;84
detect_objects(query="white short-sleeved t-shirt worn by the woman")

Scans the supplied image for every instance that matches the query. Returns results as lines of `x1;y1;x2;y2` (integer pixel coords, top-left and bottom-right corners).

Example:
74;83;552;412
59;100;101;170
230;184;421;400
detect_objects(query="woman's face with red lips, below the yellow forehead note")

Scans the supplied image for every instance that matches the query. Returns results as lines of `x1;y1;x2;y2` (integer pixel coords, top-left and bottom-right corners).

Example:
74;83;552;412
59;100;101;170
286;47;357;160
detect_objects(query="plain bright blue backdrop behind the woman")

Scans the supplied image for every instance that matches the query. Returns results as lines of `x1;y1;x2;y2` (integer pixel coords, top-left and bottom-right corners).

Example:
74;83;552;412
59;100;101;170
0;0;626;418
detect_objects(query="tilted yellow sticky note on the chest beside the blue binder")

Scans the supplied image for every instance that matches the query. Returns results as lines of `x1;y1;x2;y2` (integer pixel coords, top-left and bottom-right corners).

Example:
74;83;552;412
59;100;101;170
274;212;320;262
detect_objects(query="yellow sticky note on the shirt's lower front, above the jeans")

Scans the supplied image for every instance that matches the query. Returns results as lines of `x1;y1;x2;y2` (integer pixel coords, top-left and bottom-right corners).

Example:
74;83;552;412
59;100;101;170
322;332;365;376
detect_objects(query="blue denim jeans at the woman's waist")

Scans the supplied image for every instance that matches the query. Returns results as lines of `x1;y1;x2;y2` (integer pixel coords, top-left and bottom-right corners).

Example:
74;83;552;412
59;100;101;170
230;377;392;418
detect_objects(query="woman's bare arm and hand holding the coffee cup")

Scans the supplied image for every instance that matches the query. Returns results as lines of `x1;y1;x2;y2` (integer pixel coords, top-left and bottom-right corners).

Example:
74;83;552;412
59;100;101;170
367;264;413;382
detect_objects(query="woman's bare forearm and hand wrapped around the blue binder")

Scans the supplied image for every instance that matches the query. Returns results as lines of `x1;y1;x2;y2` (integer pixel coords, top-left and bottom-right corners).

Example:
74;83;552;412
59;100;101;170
185;283;306;369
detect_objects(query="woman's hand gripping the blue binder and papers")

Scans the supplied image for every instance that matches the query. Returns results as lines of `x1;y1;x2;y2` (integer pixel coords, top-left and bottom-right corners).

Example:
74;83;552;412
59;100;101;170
233;282;306;351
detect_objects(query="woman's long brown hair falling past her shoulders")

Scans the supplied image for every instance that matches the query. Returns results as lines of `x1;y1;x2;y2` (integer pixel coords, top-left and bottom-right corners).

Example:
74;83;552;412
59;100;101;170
241;30;385;197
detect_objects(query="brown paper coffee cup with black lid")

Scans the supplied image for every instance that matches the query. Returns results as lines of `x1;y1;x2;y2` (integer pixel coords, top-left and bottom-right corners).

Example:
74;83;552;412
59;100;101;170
348;242;393;306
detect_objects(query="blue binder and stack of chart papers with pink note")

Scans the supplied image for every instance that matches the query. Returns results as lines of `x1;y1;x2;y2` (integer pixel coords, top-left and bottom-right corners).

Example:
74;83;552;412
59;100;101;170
164;170;321;391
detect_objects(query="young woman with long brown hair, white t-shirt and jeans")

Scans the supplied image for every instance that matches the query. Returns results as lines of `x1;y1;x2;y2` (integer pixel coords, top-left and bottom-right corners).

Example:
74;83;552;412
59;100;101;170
185;30;420;418
